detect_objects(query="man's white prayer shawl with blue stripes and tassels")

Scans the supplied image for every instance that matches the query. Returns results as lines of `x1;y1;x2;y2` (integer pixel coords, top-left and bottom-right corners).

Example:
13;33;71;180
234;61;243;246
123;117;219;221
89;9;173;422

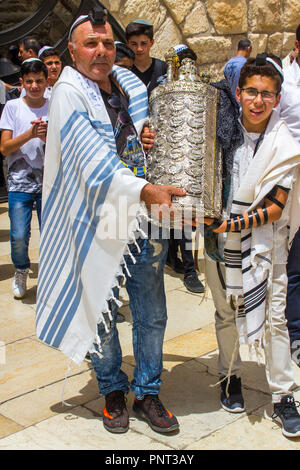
37;66;148;364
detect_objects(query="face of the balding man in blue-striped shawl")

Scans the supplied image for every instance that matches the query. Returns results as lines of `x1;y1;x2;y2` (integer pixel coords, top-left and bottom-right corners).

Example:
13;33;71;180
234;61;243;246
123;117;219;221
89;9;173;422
68;21;116;84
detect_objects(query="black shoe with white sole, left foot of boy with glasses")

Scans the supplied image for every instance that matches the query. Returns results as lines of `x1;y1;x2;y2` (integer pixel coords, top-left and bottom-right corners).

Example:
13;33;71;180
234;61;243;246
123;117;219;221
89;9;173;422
221;375;245;413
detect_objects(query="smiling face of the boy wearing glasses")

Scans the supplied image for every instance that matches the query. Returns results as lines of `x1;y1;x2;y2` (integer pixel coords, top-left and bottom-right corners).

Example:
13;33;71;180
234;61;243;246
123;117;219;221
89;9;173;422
236;75;281;133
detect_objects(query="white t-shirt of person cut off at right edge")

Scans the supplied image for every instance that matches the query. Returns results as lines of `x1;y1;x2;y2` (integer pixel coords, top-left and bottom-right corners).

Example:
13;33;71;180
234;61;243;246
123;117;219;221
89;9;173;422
279;59;300;142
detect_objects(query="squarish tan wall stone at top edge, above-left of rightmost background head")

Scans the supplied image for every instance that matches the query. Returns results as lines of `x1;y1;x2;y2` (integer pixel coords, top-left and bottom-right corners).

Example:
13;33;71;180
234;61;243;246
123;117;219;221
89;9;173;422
206;0;248;34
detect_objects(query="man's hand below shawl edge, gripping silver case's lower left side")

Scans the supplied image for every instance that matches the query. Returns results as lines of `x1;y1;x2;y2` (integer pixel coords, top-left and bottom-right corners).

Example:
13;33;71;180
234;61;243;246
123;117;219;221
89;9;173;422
141;183;186;218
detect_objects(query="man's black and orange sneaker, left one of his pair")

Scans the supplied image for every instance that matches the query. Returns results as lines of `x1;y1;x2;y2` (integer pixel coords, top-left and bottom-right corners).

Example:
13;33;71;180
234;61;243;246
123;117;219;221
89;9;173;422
102;390;129;434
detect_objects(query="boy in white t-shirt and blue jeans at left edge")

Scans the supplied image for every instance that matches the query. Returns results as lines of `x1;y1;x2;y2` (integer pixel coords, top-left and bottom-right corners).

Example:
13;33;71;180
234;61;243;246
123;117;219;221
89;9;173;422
0;59;48;299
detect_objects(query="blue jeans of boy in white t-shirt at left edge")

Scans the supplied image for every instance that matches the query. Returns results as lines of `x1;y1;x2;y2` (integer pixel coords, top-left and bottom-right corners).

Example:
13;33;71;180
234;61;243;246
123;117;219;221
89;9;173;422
8;192;42;269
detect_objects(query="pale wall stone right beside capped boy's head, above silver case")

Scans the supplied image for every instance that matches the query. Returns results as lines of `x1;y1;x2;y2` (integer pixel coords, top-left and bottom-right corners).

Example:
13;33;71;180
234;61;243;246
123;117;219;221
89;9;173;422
151;18;182;60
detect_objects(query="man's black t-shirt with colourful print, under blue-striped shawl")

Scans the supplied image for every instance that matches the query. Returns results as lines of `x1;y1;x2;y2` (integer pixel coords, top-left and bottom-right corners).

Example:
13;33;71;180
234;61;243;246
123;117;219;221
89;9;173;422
100;82;145;176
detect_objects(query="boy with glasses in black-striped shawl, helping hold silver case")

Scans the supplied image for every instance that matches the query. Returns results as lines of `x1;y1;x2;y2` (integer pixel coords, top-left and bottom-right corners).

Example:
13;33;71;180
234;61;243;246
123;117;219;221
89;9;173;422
206;54;300;437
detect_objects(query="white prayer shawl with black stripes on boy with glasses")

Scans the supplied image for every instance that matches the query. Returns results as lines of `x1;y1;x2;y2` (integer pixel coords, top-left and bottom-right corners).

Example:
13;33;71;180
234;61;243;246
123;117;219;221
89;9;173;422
224;111;300;345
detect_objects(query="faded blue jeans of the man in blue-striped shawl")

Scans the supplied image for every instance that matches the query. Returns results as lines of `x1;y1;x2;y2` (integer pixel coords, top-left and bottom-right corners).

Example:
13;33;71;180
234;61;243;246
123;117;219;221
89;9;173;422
91;239;168;399
